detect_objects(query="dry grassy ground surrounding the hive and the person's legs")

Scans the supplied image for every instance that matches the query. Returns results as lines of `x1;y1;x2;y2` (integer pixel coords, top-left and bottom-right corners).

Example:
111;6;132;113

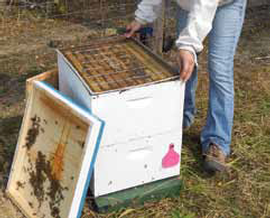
0;5;270;218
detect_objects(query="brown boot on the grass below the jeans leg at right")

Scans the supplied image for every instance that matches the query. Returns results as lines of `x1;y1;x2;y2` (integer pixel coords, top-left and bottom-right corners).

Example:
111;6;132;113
203;143;227;173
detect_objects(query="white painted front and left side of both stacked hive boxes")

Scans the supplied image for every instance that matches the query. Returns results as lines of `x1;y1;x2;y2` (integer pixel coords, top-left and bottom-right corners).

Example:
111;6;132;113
58;48;185;196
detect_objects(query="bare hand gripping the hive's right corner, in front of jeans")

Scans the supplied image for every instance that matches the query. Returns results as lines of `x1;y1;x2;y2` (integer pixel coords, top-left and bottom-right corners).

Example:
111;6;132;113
177;49;195;82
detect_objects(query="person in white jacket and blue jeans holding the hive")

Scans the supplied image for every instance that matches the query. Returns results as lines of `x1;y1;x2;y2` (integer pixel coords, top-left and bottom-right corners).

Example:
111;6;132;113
126;0;246;172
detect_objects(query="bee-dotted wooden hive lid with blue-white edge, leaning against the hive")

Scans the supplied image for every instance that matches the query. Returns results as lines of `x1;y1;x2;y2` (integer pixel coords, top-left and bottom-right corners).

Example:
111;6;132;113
7;80;104;218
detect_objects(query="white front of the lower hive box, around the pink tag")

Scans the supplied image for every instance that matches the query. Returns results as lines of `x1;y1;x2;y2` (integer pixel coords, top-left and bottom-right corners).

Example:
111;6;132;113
91;131;182;196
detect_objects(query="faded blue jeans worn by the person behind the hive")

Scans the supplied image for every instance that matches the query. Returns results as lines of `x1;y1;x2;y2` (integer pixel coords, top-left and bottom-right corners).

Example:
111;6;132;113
177;0;246;155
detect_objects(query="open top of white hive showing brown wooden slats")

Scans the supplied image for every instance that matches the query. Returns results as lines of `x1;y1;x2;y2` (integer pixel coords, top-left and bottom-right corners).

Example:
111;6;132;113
62;37;177;93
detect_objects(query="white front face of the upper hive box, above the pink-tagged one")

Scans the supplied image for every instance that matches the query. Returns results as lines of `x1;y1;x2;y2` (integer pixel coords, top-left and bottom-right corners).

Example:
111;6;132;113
91;81;185;147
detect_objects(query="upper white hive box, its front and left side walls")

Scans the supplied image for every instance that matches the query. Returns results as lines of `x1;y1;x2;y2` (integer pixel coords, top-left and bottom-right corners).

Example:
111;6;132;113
58;53;185;147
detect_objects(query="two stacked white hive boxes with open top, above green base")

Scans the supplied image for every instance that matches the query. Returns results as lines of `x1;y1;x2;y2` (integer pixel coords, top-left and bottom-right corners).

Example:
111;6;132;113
58;37;184;197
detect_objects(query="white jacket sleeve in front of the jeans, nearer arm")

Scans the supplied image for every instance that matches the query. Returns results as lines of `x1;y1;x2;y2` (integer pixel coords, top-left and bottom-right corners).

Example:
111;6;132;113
176;0;219;60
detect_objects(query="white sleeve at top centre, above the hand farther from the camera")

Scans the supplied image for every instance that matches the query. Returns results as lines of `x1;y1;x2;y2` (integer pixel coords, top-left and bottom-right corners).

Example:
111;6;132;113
135;0;162;24
